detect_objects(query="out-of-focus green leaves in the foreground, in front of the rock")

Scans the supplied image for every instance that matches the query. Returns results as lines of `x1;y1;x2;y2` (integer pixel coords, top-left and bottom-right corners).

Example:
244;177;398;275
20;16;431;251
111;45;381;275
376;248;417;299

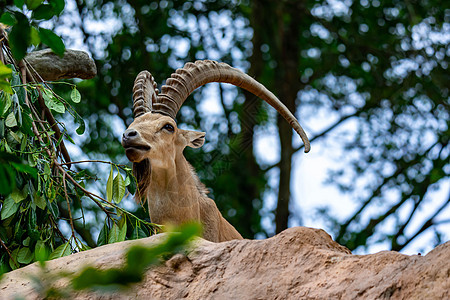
13;223;202;299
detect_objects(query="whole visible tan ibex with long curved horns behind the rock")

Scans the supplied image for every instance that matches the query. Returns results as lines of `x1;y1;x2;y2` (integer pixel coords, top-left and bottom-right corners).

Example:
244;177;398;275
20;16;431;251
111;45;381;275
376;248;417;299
122;61;310;242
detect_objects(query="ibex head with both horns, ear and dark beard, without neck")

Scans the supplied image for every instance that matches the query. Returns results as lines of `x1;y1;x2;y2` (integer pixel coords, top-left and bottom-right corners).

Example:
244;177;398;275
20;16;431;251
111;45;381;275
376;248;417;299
122;60;310;202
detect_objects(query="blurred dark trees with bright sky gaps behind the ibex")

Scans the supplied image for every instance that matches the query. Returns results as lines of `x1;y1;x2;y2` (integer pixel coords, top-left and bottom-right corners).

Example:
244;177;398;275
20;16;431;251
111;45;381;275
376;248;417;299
51;0;450;250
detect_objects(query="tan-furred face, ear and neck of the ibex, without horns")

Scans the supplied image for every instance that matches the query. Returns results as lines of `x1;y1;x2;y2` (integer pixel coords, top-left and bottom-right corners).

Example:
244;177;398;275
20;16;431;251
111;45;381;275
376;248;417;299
122;112;242;242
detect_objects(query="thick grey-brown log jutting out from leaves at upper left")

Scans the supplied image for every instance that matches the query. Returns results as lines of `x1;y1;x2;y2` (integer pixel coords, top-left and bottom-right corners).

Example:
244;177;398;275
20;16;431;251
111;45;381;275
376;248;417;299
25;49;97;81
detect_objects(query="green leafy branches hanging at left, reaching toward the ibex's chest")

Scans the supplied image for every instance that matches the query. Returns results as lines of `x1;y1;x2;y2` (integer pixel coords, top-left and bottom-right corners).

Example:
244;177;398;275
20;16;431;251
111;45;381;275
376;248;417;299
0;24;159;274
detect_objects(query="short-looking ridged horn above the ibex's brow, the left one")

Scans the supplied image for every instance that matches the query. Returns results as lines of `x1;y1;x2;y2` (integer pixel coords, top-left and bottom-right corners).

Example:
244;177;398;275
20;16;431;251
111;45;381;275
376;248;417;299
133;71;158;118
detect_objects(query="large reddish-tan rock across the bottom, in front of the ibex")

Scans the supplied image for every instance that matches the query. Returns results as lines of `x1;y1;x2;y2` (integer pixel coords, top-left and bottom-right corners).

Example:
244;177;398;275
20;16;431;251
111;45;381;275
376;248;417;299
0;227;450;299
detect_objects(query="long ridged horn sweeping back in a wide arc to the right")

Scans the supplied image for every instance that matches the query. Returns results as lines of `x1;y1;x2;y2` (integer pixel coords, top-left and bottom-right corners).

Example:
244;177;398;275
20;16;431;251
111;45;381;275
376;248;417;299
152;60;310;152
